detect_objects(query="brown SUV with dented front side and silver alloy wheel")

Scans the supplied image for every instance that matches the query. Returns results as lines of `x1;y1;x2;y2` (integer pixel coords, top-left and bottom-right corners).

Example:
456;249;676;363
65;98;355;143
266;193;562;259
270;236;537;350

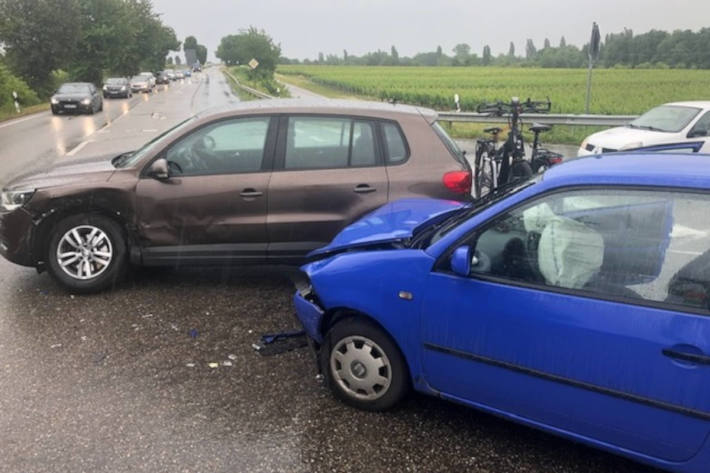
0;100;471;292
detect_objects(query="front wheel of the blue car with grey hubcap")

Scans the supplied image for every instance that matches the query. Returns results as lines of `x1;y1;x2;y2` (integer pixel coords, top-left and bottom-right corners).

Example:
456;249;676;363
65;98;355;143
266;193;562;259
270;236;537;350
320;317;409;411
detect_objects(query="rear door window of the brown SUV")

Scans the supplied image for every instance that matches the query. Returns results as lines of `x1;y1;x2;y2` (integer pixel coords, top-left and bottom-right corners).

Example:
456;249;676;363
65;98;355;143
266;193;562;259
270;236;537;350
284;116;377;169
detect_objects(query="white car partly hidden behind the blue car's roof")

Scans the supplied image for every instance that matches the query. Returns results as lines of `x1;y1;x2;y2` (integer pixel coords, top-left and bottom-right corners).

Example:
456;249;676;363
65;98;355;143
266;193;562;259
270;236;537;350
577;101;710;156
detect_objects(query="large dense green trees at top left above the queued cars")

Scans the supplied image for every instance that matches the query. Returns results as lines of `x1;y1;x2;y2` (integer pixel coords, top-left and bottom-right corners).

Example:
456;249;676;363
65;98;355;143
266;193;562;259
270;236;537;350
0;0;180;97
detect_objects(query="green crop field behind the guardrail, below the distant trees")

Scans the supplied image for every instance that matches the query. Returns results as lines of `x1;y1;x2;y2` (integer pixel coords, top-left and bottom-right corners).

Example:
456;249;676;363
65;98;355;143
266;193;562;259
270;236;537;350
278;65;710;115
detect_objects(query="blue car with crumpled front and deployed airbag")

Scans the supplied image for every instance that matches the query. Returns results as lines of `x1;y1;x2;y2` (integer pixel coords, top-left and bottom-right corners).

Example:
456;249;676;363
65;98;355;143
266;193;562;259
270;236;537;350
294;153;710;473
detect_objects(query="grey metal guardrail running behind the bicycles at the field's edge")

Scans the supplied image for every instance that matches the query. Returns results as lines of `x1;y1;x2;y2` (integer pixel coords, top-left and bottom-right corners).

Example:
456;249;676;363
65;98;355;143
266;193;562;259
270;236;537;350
438;112;638;126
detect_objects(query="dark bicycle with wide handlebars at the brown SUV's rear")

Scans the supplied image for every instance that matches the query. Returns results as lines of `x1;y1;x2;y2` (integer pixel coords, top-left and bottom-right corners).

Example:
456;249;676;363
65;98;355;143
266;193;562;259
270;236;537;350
474;97;551;198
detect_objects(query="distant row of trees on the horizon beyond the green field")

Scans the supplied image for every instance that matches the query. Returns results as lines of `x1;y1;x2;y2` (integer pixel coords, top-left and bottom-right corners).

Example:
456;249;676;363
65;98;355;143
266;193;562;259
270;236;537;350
279;28;710;69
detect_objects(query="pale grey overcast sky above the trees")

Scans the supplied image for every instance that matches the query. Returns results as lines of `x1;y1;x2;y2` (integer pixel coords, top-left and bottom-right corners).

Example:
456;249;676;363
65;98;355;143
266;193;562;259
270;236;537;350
153;0;710;59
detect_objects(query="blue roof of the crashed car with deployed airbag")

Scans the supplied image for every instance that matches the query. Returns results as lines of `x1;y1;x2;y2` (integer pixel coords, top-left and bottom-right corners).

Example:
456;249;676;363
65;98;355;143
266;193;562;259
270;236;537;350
542;153;710;189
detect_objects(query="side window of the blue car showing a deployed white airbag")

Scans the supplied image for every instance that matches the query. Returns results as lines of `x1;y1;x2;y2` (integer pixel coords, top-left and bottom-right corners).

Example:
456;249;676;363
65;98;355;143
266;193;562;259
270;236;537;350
468;188;710;313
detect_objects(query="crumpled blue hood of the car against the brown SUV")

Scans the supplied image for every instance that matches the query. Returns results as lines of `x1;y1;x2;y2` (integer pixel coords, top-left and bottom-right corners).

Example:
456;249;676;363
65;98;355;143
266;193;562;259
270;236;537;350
308;199;471;258
